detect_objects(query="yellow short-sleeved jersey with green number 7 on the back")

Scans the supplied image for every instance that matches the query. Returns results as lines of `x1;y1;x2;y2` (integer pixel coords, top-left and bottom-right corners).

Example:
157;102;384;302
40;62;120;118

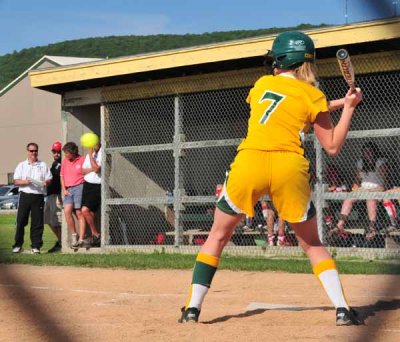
238;74;328;155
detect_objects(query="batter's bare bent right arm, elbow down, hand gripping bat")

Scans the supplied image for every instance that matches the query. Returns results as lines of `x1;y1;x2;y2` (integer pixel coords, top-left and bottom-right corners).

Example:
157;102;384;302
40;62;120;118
314;88;362;156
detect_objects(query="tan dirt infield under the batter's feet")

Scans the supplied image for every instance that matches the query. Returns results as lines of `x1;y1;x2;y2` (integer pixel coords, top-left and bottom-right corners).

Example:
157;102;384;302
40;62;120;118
0;265;400;342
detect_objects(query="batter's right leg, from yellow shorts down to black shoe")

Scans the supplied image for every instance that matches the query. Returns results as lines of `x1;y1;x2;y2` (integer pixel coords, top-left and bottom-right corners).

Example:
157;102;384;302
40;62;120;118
270;154;358;325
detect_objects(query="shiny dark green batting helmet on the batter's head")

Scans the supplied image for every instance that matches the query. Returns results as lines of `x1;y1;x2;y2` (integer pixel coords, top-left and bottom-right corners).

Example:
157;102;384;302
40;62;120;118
272;31;315;69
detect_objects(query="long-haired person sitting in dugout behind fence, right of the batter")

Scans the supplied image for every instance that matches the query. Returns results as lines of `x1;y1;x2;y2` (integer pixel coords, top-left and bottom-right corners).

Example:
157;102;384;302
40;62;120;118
334;142;387;240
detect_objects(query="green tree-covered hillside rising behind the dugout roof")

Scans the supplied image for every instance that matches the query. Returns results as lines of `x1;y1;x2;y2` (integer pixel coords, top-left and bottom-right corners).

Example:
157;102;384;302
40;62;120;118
0;24;328;89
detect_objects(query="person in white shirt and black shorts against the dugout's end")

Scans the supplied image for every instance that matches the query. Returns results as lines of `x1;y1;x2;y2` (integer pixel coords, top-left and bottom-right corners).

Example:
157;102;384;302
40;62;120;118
78;143;101;247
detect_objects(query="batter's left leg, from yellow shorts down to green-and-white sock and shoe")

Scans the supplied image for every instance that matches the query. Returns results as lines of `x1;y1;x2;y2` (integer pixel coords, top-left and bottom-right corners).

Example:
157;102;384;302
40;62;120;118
179;151;265;322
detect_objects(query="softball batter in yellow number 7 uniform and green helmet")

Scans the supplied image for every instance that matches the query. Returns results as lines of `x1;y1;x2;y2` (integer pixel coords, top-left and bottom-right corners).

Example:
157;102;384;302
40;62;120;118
179;31;362;325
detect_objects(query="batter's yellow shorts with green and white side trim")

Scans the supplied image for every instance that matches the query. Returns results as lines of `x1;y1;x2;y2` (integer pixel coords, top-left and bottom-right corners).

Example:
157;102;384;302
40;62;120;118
217;150;315;223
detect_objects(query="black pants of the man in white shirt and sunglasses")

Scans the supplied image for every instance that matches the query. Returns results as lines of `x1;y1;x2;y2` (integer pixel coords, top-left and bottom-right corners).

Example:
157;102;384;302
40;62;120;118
14;192;44;248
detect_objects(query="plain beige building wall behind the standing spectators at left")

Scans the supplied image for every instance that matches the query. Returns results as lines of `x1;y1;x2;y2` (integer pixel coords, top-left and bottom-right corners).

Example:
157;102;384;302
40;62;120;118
0;69;62;184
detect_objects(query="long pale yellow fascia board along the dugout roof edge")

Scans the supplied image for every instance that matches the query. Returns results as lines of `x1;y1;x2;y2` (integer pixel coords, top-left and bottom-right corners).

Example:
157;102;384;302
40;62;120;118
29;18;400;87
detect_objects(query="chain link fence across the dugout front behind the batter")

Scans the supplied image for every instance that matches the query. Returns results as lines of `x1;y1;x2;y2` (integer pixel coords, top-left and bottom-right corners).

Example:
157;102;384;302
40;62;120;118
102;53;400;258
